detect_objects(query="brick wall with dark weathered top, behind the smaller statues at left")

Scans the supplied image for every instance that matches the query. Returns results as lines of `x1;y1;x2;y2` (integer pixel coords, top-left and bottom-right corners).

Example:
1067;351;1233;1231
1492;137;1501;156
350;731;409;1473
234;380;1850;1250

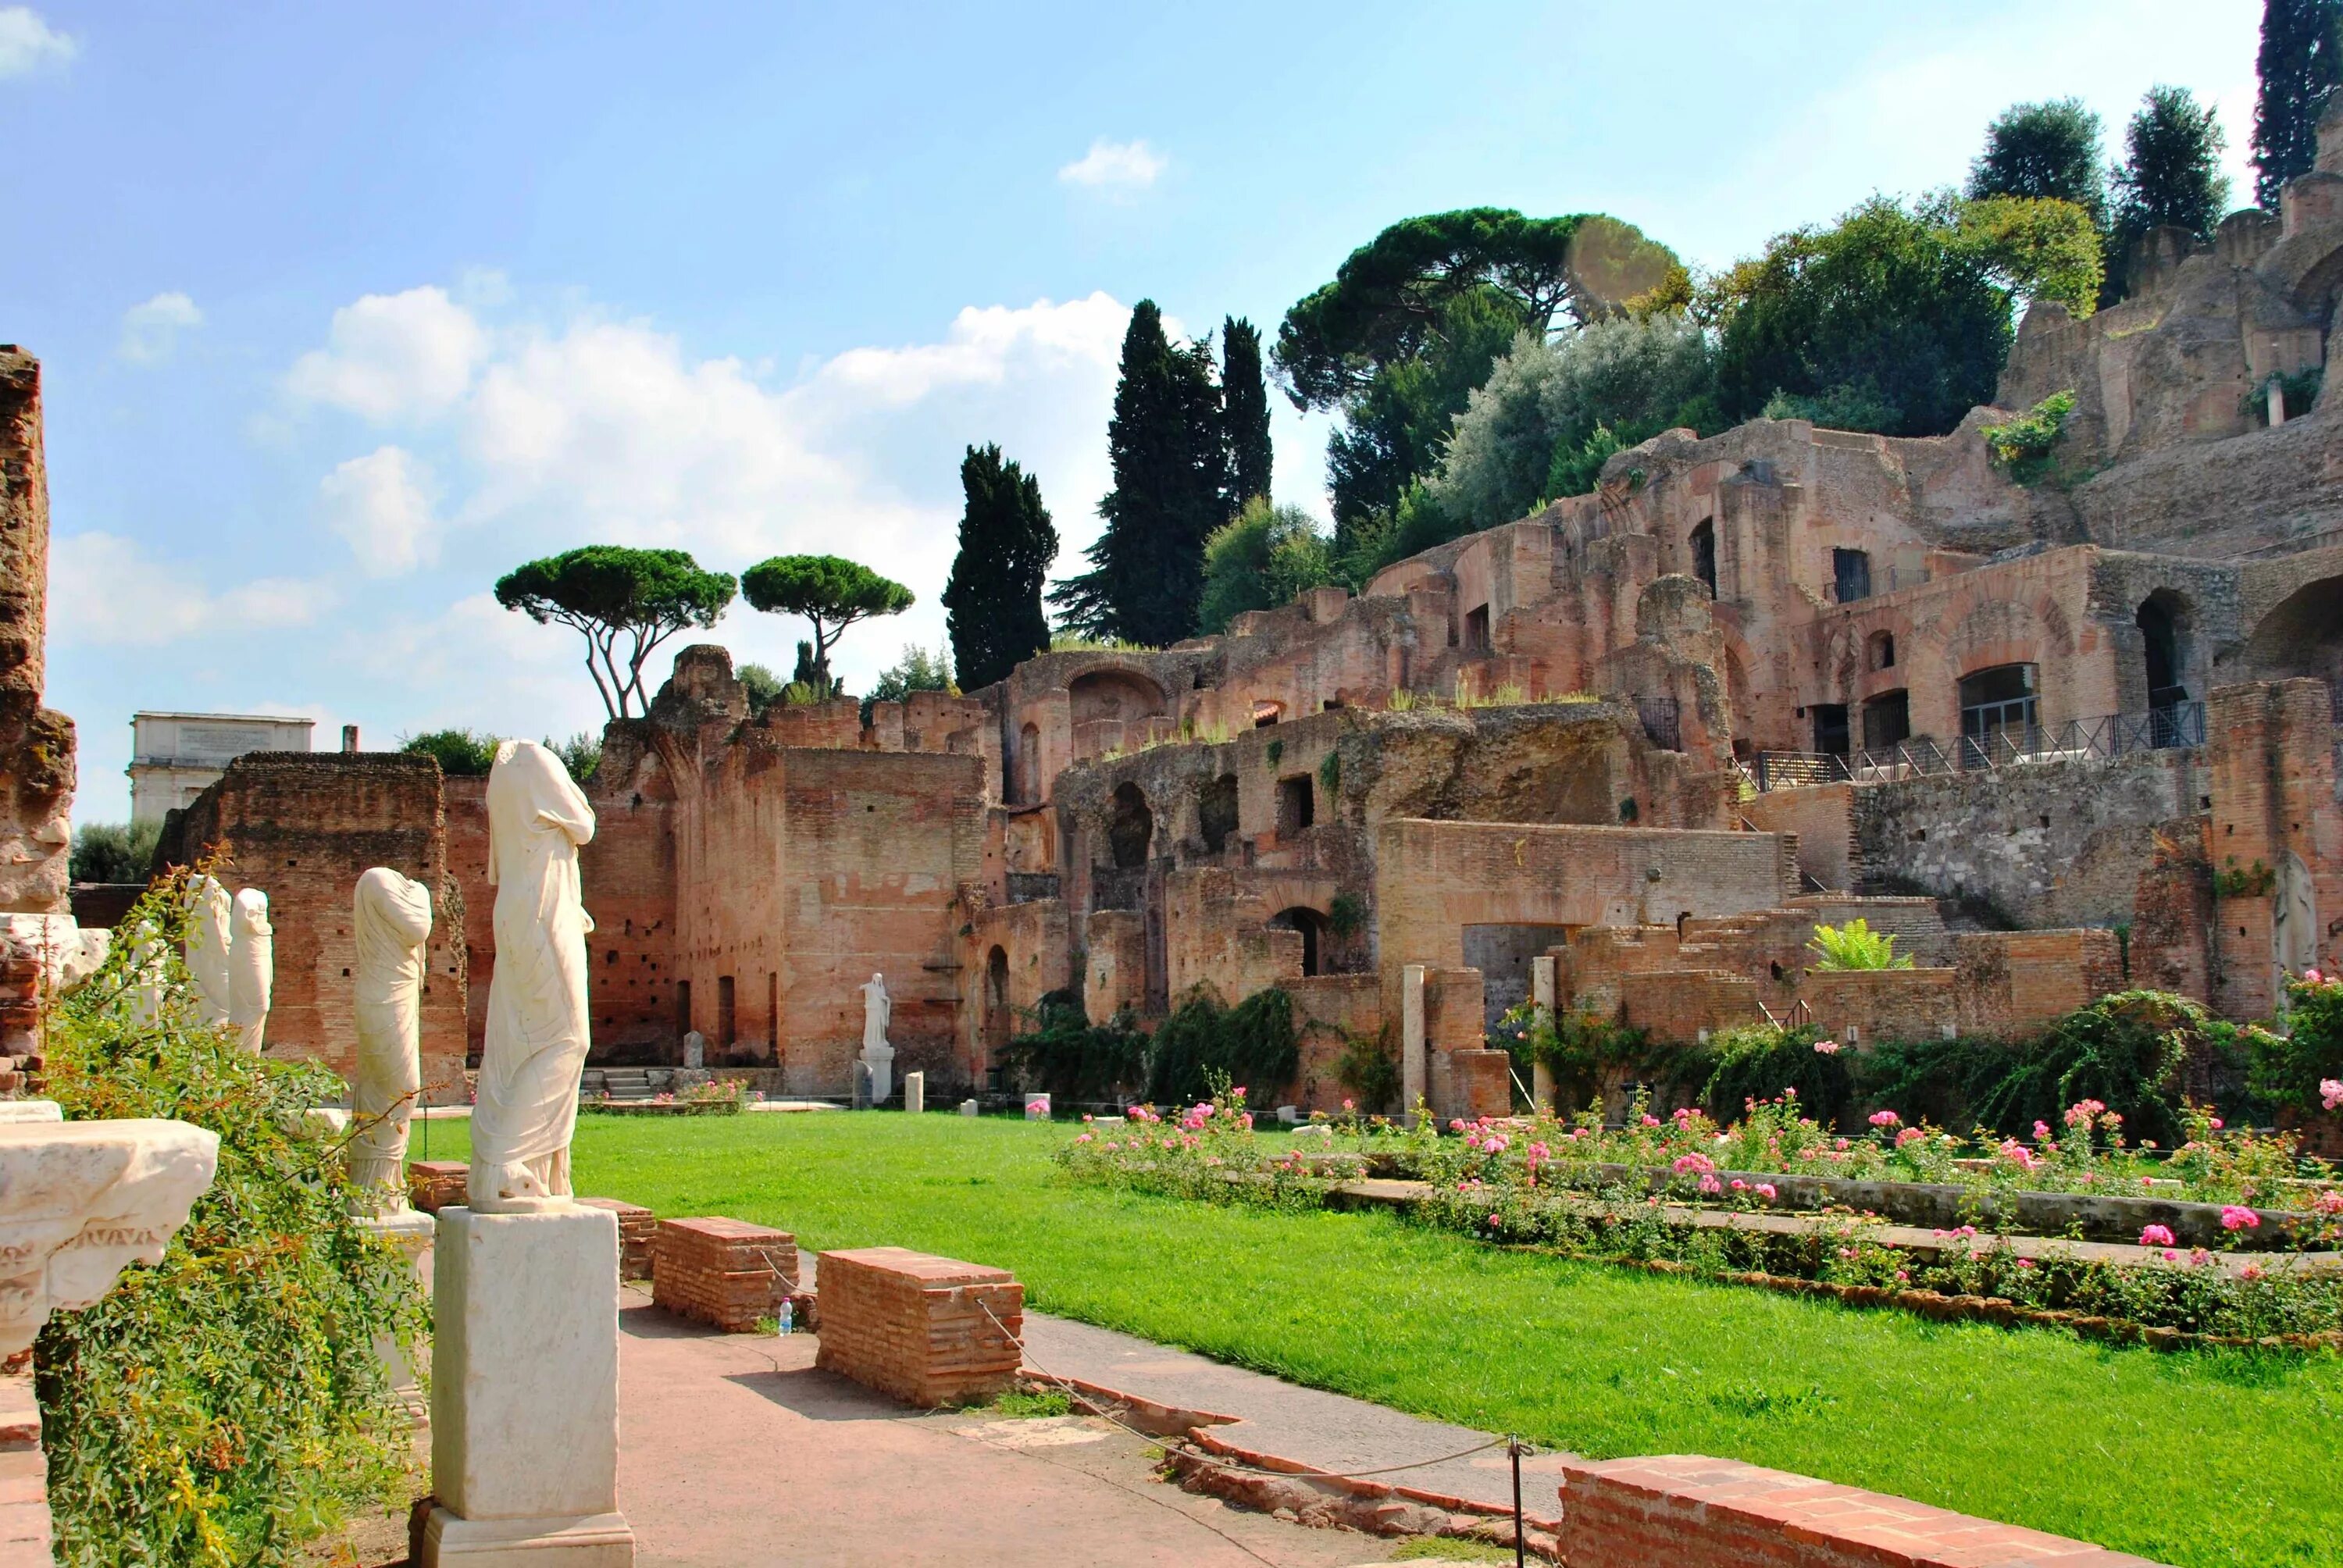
159;752;469;1087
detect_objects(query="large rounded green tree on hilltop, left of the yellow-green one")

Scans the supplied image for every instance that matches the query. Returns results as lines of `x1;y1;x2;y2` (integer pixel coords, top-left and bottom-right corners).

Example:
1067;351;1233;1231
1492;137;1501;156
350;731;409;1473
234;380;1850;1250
1717;197;2010;436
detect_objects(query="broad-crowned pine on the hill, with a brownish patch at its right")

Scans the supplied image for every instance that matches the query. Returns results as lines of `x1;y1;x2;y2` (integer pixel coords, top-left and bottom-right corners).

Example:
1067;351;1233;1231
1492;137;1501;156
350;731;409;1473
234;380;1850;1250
1272;206;1685;532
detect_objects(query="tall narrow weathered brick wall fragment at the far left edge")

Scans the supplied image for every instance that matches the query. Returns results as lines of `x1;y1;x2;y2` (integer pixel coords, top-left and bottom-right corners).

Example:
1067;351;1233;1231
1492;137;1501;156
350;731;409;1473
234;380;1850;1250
0;344;73;914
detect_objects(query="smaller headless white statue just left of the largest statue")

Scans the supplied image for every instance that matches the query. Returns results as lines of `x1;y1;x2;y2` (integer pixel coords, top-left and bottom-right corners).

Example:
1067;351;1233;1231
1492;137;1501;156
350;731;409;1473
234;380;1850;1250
349;865;431;1210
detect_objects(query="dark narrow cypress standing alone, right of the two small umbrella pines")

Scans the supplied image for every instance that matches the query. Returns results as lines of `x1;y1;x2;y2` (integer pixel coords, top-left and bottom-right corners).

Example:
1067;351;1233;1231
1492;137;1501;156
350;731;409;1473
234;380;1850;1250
944;445;1057;691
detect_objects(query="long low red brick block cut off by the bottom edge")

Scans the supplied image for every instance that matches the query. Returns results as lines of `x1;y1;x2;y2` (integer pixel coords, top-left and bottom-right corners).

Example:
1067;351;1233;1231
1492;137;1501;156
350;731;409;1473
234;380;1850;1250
1565;1452;2153;1568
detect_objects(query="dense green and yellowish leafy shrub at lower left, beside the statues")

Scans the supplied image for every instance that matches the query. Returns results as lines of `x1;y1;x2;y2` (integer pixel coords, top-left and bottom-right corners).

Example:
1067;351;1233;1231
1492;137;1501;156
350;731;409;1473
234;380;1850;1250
35;879;431;1568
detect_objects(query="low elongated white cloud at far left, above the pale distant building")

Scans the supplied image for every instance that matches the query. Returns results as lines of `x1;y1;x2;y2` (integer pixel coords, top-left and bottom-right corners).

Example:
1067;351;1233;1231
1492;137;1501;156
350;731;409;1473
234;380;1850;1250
49;534;335;647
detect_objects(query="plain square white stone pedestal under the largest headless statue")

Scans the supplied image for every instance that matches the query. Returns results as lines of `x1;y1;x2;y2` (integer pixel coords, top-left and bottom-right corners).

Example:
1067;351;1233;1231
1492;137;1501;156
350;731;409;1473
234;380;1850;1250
415;1205;635;1568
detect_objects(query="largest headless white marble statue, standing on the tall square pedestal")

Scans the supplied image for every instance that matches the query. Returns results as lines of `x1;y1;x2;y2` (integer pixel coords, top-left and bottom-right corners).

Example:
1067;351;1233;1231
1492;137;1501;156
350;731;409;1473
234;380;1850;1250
469;740;593;1214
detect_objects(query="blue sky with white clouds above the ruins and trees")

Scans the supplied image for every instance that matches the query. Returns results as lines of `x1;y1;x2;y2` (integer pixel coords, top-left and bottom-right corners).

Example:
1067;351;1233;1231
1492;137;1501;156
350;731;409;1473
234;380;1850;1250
0;0;2261;821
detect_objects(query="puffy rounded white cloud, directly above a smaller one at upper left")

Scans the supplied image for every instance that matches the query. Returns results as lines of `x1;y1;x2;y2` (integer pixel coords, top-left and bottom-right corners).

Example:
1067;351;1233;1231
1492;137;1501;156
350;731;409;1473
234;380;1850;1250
286;288;490;424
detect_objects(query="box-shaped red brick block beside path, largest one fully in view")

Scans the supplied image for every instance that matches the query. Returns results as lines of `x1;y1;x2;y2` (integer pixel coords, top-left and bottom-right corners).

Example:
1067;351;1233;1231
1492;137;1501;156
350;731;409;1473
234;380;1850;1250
813;1247;1024;1406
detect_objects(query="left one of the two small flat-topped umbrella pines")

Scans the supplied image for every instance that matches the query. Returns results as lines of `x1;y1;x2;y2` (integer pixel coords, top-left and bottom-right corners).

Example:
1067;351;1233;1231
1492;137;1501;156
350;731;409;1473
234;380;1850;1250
497;543;738;719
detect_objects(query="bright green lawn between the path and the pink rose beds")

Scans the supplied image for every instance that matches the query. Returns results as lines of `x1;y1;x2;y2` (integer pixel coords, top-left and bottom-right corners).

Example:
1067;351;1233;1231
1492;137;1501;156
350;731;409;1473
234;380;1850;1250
426;1114;2343;1566
